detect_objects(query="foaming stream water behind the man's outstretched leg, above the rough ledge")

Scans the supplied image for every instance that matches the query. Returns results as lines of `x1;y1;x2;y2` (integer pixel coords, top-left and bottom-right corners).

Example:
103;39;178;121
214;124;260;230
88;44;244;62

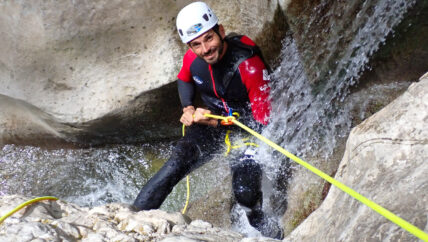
0;142;228;212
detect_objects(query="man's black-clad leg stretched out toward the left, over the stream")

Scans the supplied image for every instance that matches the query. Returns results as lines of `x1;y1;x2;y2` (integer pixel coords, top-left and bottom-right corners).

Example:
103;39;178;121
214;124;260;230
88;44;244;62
134;125;221;210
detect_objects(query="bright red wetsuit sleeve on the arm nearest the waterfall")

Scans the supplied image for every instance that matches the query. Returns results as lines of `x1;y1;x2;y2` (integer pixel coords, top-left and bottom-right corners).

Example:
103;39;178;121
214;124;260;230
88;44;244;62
239;56;271;125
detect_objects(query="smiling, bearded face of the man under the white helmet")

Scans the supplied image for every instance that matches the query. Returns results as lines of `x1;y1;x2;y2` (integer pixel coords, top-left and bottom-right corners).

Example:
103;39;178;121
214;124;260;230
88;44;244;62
188;29;224;65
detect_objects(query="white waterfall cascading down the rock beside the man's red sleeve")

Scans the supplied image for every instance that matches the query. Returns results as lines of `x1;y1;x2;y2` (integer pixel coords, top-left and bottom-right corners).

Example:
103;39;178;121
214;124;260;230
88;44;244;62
260;0;415;179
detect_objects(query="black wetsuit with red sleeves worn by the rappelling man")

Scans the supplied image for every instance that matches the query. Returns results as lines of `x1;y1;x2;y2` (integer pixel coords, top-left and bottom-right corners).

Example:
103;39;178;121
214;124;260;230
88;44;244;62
134;36;270;236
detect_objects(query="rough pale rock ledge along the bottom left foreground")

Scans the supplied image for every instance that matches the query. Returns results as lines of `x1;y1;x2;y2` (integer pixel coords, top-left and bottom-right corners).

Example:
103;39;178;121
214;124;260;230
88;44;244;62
0;196;254;241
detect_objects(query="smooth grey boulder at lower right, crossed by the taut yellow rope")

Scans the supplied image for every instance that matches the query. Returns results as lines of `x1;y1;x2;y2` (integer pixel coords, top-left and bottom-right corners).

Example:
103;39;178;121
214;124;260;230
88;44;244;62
286;73;428;241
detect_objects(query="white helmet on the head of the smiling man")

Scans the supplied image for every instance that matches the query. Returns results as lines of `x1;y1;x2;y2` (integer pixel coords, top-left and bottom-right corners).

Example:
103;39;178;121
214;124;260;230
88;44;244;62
177;2;218;43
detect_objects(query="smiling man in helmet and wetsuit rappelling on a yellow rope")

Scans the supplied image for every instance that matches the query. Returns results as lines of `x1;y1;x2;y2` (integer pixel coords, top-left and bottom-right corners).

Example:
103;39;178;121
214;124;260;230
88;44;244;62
134;2;281;237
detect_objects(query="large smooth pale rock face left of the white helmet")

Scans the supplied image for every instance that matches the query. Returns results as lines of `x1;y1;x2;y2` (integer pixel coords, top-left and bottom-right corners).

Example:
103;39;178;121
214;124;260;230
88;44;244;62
0;1;185;122
